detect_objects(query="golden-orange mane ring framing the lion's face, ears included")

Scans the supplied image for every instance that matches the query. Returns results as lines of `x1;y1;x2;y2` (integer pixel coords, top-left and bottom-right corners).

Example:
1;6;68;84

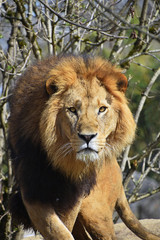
40;56;135;179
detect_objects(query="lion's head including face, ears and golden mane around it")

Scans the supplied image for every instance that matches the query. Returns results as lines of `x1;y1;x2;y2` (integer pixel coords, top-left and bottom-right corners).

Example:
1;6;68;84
40;57;135;178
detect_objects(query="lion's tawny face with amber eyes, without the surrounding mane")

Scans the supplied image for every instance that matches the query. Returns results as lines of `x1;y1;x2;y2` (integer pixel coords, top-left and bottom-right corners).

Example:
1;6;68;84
58;78;118;162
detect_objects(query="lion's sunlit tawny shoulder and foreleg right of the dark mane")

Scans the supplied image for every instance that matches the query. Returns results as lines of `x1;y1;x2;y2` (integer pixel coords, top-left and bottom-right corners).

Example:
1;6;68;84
73;159;122;240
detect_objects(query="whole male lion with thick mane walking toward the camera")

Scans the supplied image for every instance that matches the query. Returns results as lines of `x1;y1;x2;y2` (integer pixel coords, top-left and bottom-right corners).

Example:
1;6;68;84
9;55;160;240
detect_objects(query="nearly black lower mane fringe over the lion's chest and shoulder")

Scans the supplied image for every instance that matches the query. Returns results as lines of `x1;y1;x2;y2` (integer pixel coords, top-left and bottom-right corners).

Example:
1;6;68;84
9;136;96;228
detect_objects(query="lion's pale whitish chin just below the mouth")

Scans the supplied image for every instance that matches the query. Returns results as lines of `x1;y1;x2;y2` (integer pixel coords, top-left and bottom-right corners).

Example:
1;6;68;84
76;149;99;162
